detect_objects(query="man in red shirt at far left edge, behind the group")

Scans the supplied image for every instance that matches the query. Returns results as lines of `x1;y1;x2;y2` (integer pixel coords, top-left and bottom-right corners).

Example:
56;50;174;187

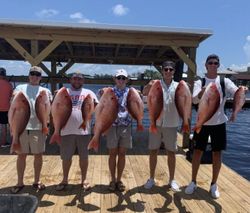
0;67;13;147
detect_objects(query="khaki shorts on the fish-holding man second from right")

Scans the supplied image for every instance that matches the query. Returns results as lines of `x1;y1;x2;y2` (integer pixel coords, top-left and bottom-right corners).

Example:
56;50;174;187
148;127;177;152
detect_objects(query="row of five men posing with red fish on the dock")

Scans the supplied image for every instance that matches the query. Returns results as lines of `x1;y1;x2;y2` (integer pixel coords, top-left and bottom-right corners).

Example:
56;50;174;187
0;54;243;198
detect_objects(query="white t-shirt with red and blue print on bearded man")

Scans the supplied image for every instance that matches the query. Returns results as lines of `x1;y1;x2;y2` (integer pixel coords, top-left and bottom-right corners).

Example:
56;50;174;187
61;88;98;135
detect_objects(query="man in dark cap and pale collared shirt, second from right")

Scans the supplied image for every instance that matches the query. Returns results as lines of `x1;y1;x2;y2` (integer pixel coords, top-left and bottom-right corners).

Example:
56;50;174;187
143;61;180;192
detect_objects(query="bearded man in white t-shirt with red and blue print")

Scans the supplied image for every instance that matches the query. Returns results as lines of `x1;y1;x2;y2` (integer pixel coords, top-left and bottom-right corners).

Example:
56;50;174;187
56;72;98;191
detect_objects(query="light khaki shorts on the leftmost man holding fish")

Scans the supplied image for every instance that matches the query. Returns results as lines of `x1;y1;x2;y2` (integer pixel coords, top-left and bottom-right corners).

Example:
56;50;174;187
20;130;46;154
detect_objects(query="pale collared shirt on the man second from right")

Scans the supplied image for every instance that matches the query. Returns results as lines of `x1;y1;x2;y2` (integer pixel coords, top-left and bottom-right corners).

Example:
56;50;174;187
156;80;180;127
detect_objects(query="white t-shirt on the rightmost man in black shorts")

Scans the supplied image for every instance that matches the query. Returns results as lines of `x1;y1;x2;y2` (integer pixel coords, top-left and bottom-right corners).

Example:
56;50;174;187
193;76;238;125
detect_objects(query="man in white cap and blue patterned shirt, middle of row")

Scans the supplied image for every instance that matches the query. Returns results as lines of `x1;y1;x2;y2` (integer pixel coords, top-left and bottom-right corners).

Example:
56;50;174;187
97;69;132;192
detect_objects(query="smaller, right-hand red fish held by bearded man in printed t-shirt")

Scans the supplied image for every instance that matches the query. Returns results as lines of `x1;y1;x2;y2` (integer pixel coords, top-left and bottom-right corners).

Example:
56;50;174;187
79;94;95;130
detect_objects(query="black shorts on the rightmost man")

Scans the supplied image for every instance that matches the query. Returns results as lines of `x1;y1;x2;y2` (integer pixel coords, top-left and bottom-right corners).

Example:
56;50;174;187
193;123;227;151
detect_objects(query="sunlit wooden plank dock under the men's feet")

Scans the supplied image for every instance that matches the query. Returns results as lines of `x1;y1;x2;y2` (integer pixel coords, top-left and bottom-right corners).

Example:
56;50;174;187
0;133;250;213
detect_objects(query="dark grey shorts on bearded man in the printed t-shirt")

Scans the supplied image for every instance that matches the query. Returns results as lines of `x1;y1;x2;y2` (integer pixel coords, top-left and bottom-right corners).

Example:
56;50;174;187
60;135;91;160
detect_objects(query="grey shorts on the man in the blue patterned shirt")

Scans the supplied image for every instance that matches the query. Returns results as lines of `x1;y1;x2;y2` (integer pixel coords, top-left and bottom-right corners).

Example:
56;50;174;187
106;126;132;149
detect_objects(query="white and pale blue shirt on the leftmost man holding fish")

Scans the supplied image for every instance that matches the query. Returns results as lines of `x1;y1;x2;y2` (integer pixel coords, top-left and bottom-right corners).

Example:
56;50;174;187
15;84;52;130
